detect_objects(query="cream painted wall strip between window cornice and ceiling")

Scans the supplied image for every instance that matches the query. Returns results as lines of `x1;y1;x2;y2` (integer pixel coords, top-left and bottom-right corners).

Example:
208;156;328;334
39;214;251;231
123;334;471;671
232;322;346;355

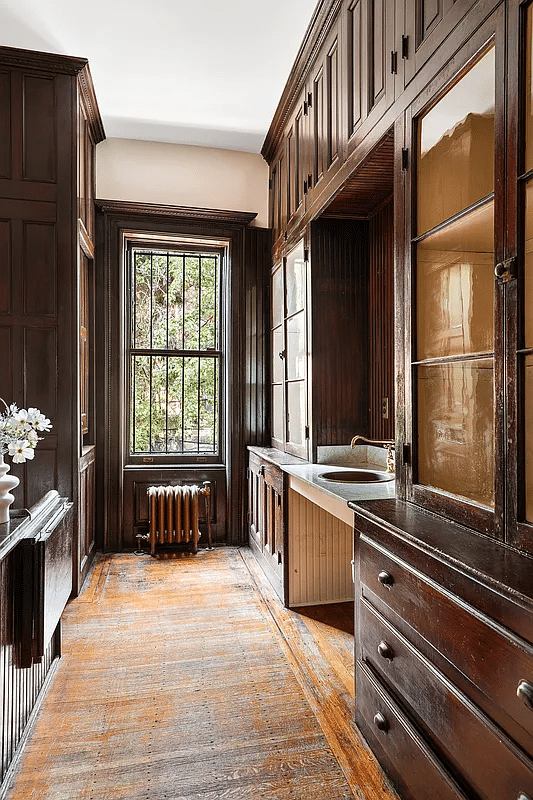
96;139;268;228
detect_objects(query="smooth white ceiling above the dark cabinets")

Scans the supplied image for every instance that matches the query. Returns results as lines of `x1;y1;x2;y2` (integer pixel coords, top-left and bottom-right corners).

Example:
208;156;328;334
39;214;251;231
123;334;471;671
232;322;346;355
0;0;316;153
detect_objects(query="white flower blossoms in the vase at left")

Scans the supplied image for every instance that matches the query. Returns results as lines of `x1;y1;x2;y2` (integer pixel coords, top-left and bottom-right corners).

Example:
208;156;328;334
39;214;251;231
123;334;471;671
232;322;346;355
0;397;52;464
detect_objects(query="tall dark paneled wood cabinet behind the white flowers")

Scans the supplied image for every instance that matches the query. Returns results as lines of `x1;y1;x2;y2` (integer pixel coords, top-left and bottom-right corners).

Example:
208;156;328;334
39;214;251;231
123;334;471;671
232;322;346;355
0;47;104;592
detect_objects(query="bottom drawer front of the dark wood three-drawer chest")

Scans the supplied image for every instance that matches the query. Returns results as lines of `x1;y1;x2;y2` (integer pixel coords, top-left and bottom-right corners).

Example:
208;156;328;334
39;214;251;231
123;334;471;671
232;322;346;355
356;661;472;800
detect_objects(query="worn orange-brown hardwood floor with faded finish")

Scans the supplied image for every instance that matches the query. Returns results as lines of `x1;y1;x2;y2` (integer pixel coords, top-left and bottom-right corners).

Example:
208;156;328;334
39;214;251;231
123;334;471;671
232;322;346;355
3;548;395;800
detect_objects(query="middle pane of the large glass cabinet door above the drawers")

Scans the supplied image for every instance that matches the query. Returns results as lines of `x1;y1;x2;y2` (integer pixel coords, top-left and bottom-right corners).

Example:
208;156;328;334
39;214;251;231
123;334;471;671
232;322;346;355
416;202;494;360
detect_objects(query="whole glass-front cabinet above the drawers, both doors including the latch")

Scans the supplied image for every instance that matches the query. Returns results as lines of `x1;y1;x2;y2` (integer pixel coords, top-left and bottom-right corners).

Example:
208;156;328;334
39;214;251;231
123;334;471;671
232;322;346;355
400;7;533;551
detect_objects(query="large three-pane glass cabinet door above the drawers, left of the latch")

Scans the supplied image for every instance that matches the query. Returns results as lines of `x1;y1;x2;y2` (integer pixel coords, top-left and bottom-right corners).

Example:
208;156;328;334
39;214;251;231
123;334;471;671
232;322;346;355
406;7;504;538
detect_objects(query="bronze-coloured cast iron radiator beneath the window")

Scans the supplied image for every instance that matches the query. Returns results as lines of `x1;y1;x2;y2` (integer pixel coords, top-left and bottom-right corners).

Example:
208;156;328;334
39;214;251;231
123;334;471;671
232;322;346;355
137;481;212;556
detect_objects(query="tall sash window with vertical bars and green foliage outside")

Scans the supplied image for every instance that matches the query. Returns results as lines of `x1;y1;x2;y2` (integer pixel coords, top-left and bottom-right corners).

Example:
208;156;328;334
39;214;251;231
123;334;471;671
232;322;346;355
127;243;223;462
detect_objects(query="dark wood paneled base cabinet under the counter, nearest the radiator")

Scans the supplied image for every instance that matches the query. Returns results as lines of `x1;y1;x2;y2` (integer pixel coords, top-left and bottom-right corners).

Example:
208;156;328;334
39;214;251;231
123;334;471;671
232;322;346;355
248;452;288;605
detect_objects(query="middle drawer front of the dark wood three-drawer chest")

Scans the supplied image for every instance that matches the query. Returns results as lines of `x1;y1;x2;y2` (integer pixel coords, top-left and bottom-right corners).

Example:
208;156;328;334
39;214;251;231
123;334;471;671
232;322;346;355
359;599;533;800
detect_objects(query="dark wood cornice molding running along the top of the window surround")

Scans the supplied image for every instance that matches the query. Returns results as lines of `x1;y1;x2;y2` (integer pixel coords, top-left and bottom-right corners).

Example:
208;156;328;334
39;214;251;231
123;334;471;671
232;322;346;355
95;200;257;225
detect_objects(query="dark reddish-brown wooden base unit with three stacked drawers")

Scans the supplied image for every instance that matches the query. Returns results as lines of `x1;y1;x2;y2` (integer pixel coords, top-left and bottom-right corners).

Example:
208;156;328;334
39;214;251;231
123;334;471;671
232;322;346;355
355;501;533;800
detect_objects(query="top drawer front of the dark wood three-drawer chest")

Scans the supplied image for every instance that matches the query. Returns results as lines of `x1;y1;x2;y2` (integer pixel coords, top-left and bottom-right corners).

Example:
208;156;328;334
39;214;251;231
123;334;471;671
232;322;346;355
359;537;533;736
